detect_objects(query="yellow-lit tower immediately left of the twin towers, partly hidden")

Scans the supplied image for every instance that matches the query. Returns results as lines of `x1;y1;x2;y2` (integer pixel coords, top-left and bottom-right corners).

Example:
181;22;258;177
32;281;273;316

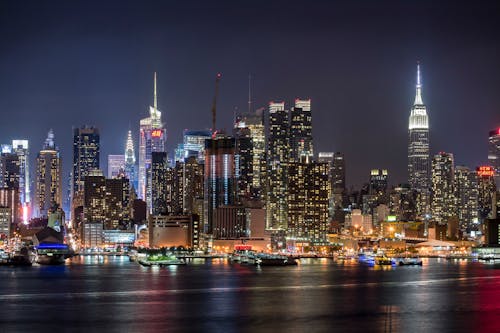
236;109;266;198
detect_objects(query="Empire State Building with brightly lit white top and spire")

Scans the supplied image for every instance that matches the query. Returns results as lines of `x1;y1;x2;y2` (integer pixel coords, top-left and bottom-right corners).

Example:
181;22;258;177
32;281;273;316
408;65;430;191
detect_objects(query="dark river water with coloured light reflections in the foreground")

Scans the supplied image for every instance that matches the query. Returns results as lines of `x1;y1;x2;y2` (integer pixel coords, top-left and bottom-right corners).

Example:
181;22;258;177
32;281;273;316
0;257;500;333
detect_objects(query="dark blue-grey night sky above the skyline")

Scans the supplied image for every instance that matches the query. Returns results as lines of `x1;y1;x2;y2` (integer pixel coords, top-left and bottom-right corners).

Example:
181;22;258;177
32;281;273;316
0;0;500;186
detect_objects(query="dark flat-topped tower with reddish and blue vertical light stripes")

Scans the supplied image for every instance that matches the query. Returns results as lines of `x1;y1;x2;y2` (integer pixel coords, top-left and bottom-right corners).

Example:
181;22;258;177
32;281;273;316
204;134;236;234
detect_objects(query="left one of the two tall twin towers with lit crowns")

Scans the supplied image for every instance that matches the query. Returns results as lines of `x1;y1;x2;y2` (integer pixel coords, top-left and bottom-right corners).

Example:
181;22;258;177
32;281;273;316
266;102;290;230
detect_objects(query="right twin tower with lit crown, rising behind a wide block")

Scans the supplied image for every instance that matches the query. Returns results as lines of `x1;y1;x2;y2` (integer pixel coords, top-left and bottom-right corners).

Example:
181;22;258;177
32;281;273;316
290;98;314;162
